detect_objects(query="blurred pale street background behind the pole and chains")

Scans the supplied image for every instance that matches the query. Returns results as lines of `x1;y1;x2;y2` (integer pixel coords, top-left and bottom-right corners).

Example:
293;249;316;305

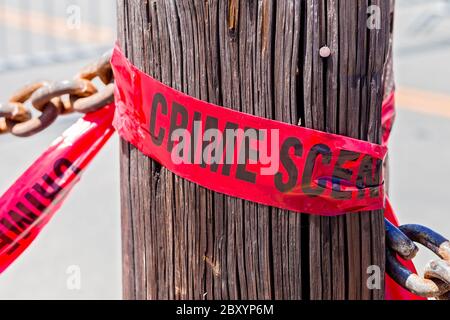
0;0;450;299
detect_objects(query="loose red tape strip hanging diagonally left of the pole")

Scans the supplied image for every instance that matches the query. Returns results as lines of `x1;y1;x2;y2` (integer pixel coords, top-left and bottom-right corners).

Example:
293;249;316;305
0;105;114;273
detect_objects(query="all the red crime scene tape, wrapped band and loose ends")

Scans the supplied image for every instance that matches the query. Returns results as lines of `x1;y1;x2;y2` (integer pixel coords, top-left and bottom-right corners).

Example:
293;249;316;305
0;46;422;300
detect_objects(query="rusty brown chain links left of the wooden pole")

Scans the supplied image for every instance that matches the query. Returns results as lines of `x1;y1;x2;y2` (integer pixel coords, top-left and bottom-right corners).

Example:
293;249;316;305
0;51;114;137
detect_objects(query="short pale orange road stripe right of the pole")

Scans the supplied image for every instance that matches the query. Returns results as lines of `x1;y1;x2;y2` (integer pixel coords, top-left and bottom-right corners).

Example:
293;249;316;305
396;87;450;118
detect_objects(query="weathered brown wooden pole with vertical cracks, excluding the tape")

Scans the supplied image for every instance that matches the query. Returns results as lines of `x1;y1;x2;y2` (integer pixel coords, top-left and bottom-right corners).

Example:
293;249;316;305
118;0;392;299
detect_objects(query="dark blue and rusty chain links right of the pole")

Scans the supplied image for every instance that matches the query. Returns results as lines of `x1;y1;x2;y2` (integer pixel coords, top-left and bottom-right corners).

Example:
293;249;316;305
386;220;450;300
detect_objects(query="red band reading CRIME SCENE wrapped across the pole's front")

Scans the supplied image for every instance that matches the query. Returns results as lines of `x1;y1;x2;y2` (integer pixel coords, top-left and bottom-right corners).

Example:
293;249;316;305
111;46;387;216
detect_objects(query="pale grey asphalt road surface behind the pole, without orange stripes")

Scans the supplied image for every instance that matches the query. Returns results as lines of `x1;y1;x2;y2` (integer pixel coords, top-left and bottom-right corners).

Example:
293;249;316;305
0;0;450;299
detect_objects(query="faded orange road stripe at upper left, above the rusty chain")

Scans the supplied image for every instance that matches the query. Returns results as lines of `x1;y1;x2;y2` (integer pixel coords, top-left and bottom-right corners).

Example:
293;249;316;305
0;5;114;44
